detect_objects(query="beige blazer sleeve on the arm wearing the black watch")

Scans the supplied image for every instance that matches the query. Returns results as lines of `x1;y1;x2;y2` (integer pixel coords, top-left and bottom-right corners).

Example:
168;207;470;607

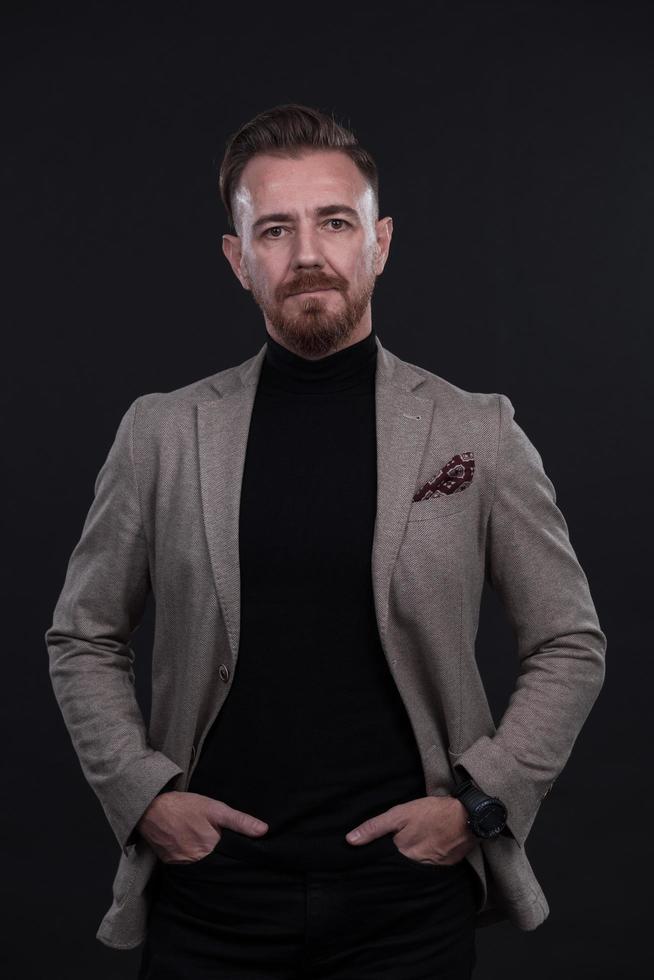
455;395;606;846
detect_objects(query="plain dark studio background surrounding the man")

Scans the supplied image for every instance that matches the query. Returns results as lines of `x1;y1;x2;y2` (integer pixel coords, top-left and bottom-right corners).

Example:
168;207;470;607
0;0;654;980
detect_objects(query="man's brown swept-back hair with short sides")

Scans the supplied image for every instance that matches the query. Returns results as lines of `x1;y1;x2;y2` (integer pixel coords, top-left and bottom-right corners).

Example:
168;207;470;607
218;102;379;231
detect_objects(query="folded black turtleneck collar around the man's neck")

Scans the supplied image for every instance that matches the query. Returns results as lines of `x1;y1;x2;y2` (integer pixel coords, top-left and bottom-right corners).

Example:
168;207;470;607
262;330;377;393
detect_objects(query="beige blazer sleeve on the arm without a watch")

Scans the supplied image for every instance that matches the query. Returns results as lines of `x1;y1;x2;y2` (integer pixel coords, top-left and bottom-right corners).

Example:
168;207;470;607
45;398;183;854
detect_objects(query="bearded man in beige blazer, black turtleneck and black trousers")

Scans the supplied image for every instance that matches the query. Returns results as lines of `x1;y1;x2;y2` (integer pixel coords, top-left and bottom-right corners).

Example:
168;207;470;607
46;105;606;980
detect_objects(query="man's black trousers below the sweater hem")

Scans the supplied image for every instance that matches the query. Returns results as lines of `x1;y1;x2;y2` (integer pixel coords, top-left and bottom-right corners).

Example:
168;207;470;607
138;848;479;980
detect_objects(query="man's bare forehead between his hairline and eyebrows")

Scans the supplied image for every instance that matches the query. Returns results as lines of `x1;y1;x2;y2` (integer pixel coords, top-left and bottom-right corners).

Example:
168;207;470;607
235;150;372;217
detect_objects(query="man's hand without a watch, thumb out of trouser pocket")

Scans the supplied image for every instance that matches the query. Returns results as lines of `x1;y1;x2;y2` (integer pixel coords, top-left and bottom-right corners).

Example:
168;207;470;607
136;790;268;864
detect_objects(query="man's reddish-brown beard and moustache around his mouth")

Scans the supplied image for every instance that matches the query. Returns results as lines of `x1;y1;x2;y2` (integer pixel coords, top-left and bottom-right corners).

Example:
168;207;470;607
250;269;377;358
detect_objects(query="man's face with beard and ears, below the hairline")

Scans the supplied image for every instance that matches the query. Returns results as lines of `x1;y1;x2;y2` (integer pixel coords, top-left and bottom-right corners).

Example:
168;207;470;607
223;150;393;358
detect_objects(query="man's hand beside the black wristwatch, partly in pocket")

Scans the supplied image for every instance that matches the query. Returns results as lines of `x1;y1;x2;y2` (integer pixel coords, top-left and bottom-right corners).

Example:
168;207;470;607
345;796;479;864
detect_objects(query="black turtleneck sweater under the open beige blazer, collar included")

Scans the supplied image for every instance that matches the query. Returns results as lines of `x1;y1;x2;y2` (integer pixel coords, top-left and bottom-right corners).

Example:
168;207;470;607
188;332;426;870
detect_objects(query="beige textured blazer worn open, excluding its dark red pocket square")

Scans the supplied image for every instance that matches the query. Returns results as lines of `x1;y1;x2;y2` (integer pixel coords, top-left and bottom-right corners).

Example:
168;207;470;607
45;337;606;949
